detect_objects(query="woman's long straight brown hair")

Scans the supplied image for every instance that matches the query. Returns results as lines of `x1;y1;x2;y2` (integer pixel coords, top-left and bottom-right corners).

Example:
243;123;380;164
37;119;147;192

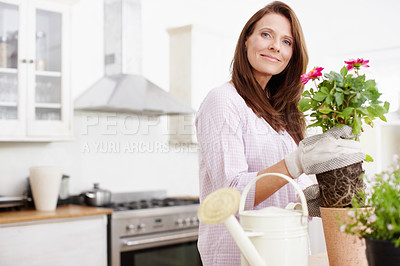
232;1;308;144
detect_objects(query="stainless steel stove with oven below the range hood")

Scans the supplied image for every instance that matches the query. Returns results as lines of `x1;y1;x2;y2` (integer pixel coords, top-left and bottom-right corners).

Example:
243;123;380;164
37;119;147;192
108;191;201;266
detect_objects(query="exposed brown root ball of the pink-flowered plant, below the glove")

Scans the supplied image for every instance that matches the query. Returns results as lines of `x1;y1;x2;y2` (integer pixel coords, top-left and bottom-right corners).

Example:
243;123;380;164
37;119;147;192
316;162;364;208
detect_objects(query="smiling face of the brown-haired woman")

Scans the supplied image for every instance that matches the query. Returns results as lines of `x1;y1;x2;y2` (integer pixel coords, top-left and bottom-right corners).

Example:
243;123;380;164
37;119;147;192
246;13;293;88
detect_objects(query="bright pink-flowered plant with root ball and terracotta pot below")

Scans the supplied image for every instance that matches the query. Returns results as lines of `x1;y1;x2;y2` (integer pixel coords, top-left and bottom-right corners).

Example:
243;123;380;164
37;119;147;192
298;59;389;266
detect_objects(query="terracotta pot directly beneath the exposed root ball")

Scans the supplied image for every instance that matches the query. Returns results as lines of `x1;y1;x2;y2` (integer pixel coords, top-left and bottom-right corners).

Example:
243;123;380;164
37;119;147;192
320;207;368;266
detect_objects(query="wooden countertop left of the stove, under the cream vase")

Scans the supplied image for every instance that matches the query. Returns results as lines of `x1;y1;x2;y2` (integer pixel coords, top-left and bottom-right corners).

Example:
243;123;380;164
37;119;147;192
0;205;112;224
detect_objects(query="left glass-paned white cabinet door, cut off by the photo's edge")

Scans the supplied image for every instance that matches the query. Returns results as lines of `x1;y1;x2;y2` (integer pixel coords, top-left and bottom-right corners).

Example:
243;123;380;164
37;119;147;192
0;1;26;137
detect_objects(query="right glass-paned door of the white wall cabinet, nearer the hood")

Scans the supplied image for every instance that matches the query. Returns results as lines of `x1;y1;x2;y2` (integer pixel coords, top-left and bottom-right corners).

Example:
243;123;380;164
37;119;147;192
27;1;72;137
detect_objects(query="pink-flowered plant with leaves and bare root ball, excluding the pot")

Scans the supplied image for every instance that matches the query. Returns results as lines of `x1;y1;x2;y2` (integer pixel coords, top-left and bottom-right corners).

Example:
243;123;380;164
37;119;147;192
299;59;389;208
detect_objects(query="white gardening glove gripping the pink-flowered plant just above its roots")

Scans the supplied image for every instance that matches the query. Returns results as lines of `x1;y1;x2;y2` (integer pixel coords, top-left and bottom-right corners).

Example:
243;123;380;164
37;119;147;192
285;125;365;178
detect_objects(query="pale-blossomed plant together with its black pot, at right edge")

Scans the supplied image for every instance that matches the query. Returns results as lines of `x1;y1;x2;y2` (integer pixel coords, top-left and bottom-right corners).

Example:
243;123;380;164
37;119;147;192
340;155;400;266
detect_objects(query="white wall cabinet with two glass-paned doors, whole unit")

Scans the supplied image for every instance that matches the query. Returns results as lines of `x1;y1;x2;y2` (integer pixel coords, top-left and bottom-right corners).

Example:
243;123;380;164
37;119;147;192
0;0;72;141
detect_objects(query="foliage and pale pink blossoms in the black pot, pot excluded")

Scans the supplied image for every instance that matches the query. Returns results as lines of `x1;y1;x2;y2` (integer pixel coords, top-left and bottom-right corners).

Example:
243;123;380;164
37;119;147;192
340;155;400;247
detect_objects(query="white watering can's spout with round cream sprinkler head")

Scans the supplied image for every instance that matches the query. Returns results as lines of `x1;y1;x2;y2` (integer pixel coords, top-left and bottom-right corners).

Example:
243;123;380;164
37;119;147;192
198;188;265;266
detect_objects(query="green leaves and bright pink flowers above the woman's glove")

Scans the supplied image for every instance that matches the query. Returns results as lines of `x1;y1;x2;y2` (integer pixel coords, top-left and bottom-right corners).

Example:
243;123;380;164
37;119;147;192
298;59;389;136
